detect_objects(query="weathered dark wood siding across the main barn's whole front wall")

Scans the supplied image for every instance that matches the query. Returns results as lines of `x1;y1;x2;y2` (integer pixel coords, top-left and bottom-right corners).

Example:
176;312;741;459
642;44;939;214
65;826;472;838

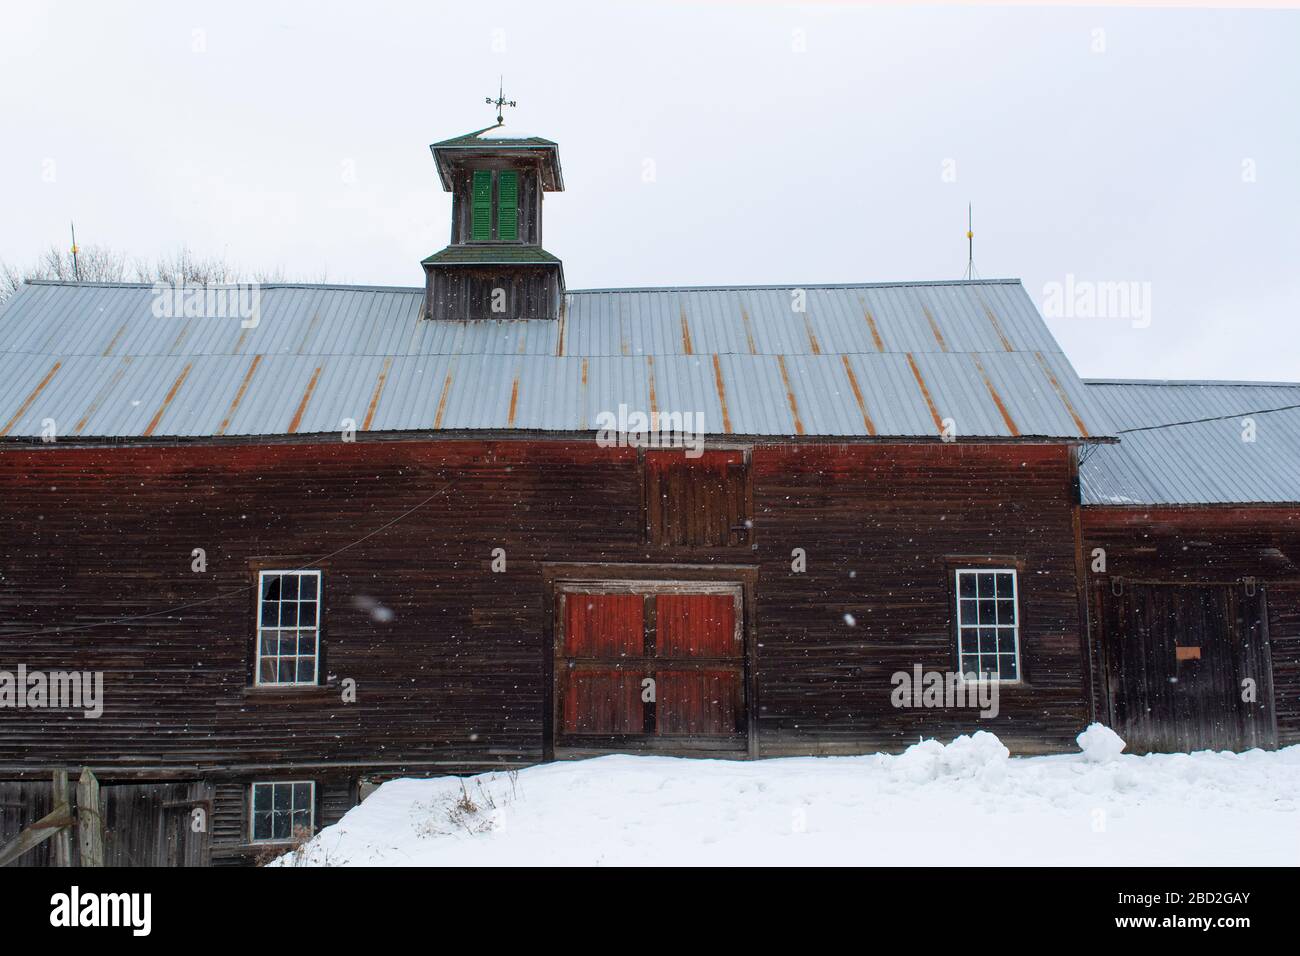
0;441;1087;852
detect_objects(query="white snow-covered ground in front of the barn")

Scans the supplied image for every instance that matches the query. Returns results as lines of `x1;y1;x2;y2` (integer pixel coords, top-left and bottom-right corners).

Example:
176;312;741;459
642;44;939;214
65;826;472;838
277;724;1300;866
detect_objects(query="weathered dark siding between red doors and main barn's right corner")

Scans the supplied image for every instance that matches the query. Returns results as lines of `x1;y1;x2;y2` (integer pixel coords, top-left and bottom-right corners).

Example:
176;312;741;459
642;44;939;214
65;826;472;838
754;445;1088;754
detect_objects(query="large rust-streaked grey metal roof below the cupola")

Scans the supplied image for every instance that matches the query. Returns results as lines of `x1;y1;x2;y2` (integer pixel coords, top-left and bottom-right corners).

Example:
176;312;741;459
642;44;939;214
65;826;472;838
0;281;1113;441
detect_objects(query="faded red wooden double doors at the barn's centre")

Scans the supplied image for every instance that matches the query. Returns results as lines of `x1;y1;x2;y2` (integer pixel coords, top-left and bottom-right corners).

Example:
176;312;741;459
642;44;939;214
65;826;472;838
555;584;745;750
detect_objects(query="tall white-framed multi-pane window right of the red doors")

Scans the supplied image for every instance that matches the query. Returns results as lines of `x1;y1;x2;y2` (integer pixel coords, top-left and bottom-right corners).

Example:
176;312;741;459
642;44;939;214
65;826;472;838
957;567;1021;682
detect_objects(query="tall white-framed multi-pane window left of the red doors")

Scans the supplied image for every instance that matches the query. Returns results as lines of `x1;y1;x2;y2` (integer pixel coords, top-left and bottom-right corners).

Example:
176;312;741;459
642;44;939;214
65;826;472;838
254;571;321;687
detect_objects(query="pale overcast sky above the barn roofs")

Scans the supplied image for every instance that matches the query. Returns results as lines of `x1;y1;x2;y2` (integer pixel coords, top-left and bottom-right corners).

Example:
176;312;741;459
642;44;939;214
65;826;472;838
0;0;1300;380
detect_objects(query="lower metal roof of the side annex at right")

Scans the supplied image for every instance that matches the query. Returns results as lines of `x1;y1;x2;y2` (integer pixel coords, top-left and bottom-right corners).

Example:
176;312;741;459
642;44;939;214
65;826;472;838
1080;381;1300;506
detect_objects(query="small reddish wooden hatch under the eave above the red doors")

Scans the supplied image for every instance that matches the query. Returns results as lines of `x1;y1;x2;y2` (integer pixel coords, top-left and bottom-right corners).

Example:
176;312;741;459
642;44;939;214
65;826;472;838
645;450;753;548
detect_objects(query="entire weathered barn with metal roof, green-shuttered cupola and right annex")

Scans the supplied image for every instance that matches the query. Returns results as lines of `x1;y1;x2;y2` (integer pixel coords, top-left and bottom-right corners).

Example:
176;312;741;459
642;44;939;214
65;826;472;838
0;126;1300;864
